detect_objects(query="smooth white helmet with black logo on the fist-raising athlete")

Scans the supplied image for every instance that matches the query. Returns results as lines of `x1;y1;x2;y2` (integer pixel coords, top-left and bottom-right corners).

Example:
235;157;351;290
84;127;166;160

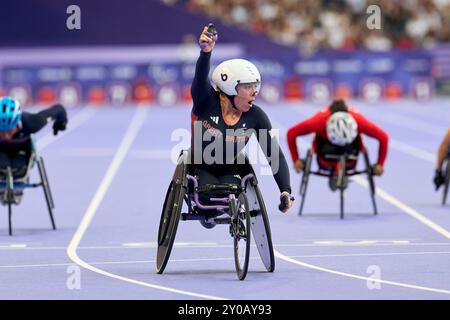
212;59;261;96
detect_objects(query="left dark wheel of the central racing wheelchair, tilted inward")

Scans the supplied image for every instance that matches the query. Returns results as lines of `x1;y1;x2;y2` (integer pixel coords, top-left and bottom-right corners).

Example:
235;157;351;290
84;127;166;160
156;156;186;274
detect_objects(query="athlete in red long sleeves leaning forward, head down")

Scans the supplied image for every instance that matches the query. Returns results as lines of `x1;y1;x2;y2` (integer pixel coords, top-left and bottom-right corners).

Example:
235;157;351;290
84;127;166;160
287;100;388;186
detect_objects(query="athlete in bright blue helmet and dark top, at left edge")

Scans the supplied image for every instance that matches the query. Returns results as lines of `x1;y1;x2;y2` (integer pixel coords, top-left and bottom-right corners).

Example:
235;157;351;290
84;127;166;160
0;97;67;177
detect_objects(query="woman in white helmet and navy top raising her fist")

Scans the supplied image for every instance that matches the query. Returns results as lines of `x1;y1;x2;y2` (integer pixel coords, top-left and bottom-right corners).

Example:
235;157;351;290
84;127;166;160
191;27;293;212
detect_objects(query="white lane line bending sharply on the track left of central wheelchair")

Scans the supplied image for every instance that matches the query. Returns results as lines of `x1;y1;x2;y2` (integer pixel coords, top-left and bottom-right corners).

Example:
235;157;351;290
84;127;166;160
67;107;224;299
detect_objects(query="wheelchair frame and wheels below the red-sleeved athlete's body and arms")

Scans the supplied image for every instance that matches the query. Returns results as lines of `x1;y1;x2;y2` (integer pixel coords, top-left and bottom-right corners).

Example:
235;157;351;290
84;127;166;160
298;147;378;219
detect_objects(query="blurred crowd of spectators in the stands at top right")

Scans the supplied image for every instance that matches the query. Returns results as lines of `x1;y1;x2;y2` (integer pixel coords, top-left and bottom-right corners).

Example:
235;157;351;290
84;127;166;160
162;0;450;52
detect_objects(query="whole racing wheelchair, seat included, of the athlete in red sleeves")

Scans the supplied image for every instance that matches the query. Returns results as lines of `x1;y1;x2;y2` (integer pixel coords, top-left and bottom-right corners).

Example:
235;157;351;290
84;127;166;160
299;136;378;219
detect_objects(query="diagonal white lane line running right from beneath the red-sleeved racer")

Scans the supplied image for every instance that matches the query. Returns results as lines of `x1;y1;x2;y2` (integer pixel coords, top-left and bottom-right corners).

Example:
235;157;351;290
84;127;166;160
353;176;450;239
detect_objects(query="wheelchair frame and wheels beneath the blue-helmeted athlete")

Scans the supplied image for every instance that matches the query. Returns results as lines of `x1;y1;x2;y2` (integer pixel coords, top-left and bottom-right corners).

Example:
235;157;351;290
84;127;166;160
0;135;56;236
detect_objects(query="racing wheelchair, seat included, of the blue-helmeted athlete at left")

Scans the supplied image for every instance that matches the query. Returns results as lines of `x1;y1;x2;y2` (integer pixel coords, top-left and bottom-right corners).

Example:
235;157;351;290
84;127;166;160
0;135;56;236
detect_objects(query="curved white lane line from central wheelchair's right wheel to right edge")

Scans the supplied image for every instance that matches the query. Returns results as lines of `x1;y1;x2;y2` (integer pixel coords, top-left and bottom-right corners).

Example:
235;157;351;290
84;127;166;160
275;250;450;294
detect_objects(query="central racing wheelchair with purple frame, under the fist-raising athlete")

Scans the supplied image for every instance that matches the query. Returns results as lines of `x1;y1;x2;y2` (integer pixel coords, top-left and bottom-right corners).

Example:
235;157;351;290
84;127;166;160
156;150;275;280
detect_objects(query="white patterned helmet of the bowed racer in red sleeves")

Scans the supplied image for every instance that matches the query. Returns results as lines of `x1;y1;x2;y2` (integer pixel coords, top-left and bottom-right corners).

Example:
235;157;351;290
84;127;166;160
326;111;358;146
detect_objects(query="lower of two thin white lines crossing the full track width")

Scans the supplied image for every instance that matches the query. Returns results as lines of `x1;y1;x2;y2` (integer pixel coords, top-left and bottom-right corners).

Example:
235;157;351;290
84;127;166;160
5;251;450;269
